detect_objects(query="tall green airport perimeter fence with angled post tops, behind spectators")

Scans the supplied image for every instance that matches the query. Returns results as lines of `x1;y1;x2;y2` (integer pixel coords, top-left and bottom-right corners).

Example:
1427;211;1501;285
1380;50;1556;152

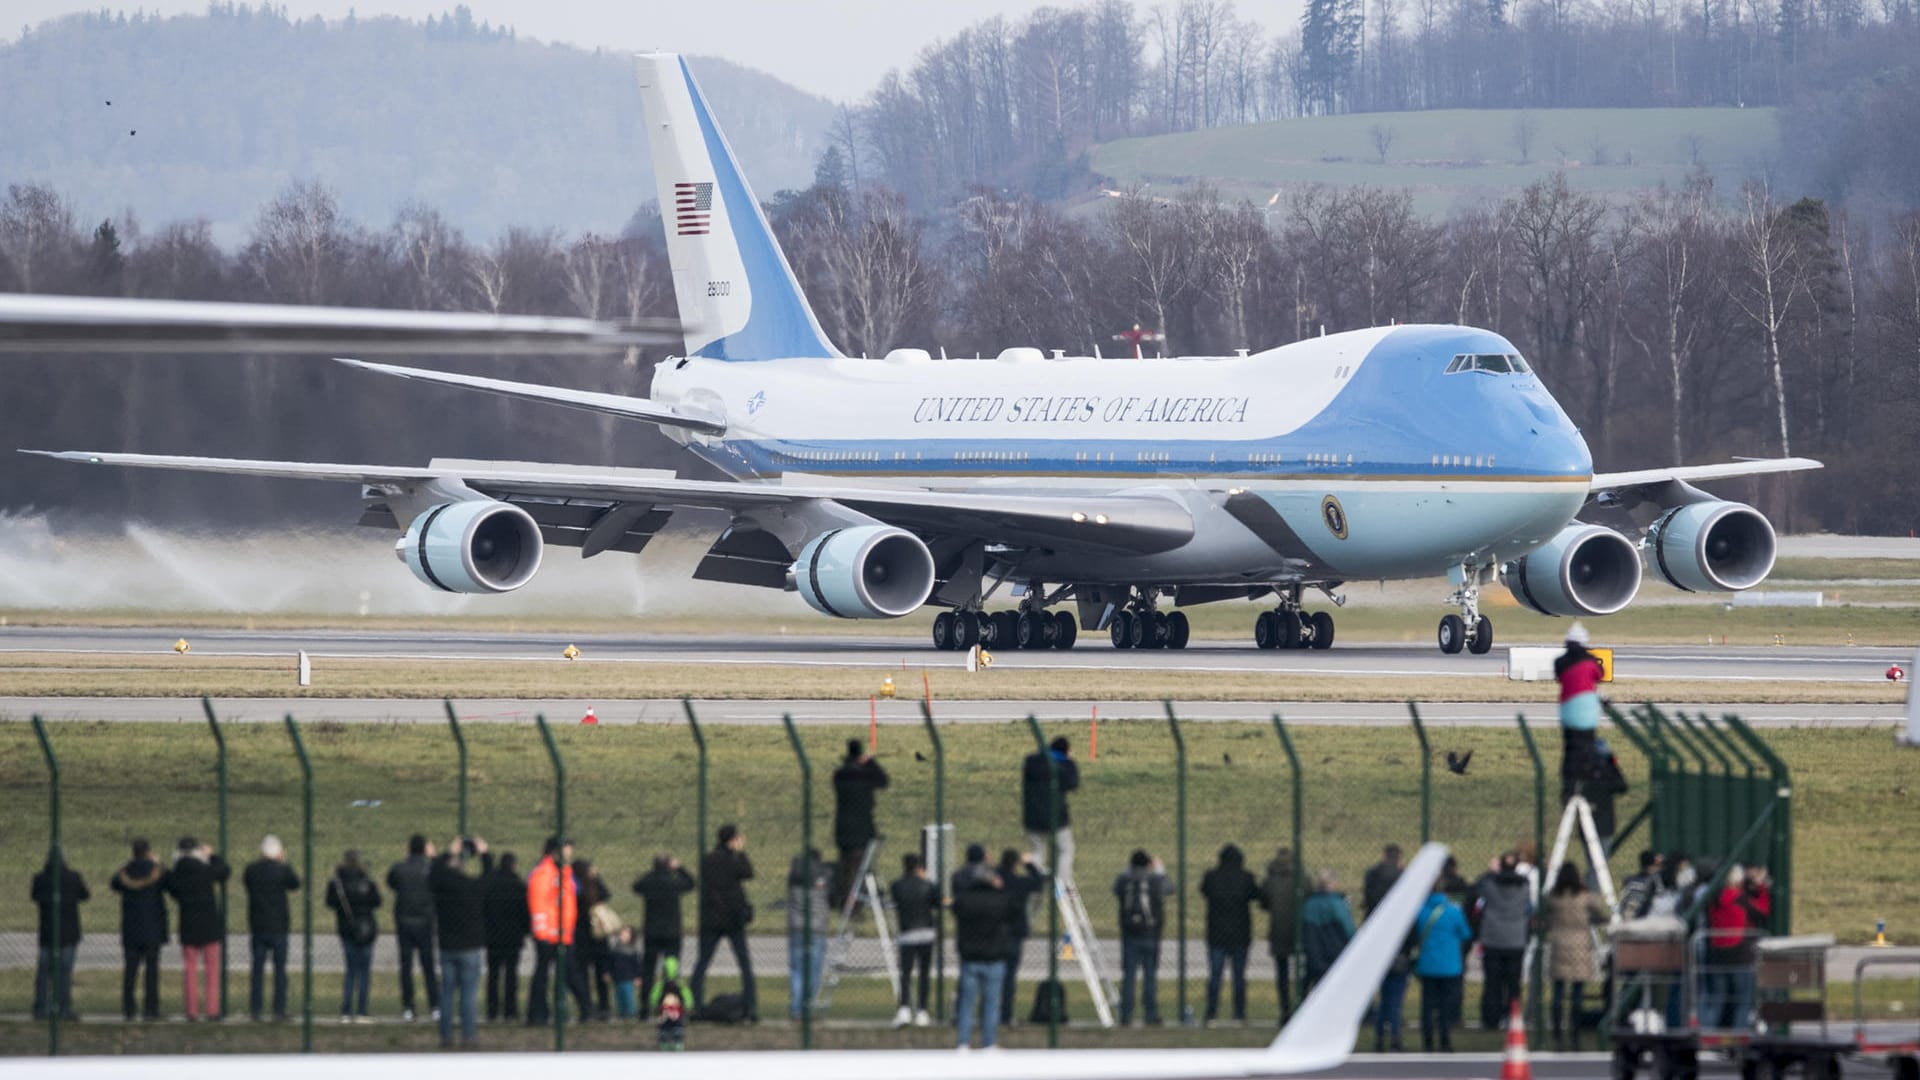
0;691;1791;1053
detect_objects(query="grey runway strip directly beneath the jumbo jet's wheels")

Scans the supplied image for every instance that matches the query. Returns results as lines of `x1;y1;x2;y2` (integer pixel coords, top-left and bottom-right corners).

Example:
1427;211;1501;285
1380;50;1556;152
0;626;1914;680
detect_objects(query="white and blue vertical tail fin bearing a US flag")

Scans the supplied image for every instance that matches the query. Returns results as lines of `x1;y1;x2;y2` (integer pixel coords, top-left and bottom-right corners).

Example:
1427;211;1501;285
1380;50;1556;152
634;52;839;359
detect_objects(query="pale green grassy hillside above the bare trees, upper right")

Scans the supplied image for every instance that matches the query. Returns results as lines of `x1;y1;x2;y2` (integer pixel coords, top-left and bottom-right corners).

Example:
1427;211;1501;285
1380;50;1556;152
1091;110;1778;213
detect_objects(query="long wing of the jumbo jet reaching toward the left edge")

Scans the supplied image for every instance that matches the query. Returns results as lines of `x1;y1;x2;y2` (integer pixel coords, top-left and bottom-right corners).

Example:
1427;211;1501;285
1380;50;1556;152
23;450;1194;555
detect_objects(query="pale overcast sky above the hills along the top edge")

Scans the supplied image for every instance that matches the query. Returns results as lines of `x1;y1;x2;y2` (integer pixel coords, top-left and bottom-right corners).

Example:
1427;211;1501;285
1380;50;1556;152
0;0;1300;102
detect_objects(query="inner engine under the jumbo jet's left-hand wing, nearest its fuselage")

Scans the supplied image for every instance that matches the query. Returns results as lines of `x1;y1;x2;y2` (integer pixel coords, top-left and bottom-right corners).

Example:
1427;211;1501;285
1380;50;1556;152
793;525;933;619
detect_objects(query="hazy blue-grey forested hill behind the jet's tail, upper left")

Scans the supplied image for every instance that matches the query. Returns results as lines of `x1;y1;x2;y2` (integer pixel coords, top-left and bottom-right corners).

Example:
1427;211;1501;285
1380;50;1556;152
0;4;833;242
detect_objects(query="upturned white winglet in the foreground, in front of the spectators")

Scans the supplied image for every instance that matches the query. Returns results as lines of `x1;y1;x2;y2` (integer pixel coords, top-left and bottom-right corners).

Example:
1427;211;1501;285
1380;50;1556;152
1267;844;1446;1070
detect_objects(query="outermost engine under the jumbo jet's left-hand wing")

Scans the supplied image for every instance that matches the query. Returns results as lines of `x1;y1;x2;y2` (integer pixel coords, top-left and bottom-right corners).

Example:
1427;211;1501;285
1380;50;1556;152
394;500;543;592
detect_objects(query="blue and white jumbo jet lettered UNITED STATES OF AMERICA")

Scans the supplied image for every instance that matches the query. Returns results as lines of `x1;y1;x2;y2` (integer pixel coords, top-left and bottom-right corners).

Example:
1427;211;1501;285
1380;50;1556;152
18;54;1818;653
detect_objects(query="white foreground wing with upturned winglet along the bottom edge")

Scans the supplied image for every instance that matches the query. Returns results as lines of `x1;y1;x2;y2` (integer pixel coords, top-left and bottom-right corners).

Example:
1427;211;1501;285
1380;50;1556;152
8;844;1446;1080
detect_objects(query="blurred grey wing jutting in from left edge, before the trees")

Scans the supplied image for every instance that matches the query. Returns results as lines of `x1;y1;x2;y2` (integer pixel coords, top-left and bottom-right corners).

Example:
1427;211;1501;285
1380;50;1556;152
0;294;682;356
